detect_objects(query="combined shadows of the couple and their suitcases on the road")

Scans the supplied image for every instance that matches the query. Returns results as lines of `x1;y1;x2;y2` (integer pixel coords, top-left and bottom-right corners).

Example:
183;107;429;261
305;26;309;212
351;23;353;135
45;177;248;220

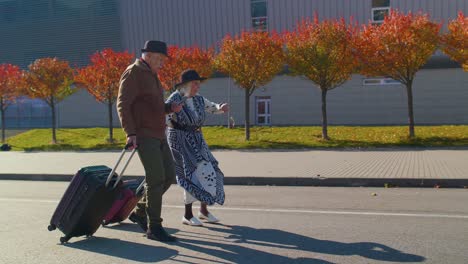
60;224;425;264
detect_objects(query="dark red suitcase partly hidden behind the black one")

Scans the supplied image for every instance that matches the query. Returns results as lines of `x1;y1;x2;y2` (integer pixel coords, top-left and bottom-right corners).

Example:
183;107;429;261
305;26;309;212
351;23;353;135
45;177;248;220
102;177;145;226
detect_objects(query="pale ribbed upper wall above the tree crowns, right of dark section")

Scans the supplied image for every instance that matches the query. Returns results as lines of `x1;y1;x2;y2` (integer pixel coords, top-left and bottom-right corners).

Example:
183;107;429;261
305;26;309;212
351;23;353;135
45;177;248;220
121;0;468;54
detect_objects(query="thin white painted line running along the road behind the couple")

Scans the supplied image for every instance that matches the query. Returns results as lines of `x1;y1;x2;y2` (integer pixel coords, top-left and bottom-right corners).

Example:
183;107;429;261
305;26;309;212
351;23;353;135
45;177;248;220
0;197;468;219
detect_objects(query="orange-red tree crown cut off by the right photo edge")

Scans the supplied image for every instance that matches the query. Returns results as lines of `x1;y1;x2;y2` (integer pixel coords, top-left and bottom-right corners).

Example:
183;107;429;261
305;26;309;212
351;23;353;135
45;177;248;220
441;12;468;71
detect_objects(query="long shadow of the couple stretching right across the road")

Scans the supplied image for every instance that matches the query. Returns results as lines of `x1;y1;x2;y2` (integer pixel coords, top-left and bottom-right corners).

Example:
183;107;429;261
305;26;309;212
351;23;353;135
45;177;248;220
177;225;425;263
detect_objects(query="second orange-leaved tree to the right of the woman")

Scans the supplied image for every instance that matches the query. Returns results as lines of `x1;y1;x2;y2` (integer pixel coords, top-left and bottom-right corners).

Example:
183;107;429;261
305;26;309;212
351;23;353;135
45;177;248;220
284;16;356;140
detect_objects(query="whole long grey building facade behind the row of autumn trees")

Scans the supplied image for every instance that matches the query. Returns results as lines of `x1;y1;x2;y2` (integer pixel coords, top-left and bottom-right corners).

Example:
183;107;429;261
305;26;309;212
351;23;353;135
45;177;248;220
0;0;468;127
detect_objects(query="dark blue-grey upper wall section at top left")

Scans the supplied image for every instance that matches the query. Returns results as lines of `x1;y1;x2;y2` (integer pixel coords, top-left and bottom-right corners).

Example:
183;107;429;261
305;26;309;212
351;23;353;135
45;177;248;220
0;0;121;67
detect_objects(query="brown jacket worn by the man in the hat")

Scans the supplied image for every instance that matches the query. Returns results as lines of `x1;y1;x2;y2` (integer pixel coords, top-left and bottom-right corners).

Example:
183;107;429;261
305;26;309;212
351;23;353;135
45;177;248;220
117;59;171;139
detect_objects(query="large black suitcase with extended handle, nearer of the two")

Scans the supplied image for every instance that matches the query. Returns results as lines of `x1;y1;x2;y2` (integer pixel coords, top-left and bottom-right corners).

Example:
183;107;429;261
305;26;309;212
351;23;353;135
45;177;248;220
48;147;136;243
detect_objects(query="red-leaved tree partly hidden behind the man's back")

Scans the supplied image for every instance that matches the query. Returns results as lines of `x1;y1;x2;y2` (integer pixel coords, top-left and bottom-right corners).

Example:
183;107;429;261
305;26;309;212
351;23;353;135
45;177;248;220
75;48;134;143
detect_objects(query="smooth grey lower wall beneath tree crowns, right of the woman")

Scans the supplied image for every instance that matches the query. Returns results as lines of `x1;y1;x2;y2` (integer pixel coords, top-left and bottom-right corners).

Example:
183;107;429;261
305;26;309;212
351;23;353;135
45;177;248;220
200;68;468;126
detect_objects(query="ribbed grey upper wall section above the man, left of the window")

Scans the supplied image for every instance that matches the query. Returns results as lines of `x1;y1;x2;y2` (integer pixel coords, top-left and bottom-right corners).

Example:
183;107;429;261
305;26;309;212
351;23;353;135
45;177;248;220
121;0;250;54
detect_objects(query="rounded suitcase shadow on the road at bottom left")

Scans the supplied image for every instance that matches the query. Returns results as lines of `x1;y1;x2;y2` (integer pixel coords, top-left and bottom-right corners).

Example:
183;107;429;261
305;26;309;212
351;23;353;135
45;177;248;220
64;237;179;263
